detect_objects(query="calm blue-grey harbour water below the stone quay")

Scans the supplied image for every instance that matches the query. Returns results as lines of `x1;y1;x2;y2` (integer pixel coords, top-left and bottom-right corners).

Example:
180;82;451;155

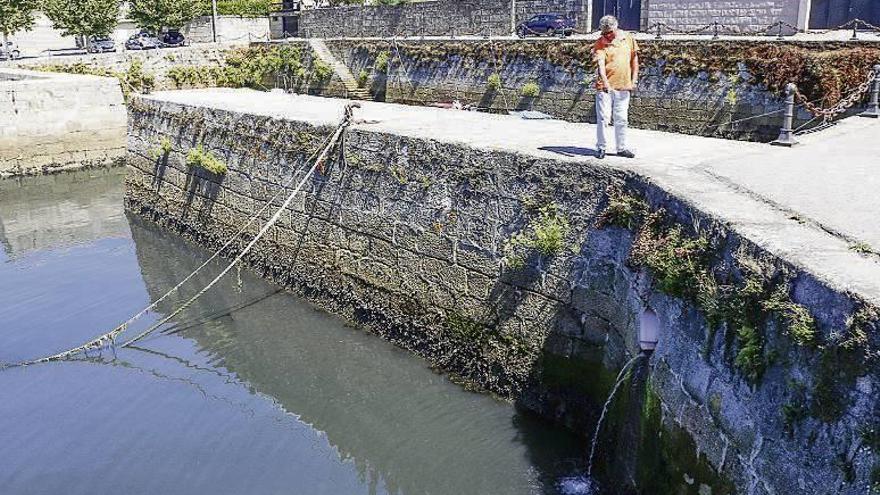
0;170;586;495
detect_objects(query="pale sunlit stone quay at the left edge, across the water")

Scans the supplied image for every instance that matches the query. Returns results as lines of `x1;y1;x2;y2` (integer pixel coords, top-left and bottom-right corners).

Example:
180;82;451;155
0;69;126;177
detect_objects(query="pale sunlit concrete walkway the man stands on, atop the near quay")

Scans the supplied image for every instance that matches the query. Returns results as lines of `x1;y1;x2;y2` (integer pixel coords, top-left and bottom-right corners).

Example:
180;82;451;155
141;89;880;304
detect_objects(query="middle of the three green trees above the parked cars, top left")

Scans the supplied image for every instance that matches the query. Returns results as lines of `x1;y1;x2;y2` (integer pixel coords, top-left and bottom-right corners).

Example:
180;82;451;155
43;0;119;46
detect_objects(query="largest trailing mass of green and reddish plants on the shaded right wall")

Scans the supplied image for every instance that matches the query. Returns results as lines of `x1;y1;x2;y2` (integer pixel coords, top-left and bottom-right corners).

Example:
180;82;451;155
597;188;824;383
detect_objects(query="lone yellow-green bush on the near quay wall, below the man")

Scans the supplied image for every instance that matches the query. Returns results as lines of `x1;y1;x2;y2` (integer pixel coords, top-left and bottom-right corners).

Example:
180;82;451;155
502;203;571;270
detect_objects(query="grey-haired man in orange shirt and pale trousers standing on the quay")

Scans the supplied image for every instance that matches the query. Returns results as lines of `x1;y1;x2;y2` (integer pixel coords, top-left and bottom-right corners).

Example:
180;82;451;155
593;15;639;158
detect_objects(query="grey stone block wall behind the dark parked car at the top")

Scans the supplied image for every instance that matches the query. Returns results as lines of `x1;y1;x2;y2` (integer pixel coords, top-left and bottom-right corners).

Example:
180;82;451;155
298;0;592;38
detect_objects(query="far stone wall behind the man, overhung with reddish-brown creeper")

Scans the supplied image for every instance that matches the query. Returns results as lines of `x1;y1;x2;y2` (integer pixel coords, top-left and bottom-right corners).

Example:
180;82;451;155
327;40;812;142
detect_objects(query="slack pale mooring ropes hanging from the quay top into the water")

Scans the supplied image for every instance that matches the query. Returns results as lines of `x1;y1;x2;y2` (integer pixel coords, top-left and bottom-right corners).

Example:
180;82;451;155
0;103;360;368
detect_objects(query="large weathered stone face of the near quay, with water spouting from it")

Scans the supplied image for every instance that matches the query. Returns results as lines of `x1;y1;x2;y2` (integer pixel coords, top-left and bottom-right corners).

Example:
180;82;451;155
126;94;880;495
